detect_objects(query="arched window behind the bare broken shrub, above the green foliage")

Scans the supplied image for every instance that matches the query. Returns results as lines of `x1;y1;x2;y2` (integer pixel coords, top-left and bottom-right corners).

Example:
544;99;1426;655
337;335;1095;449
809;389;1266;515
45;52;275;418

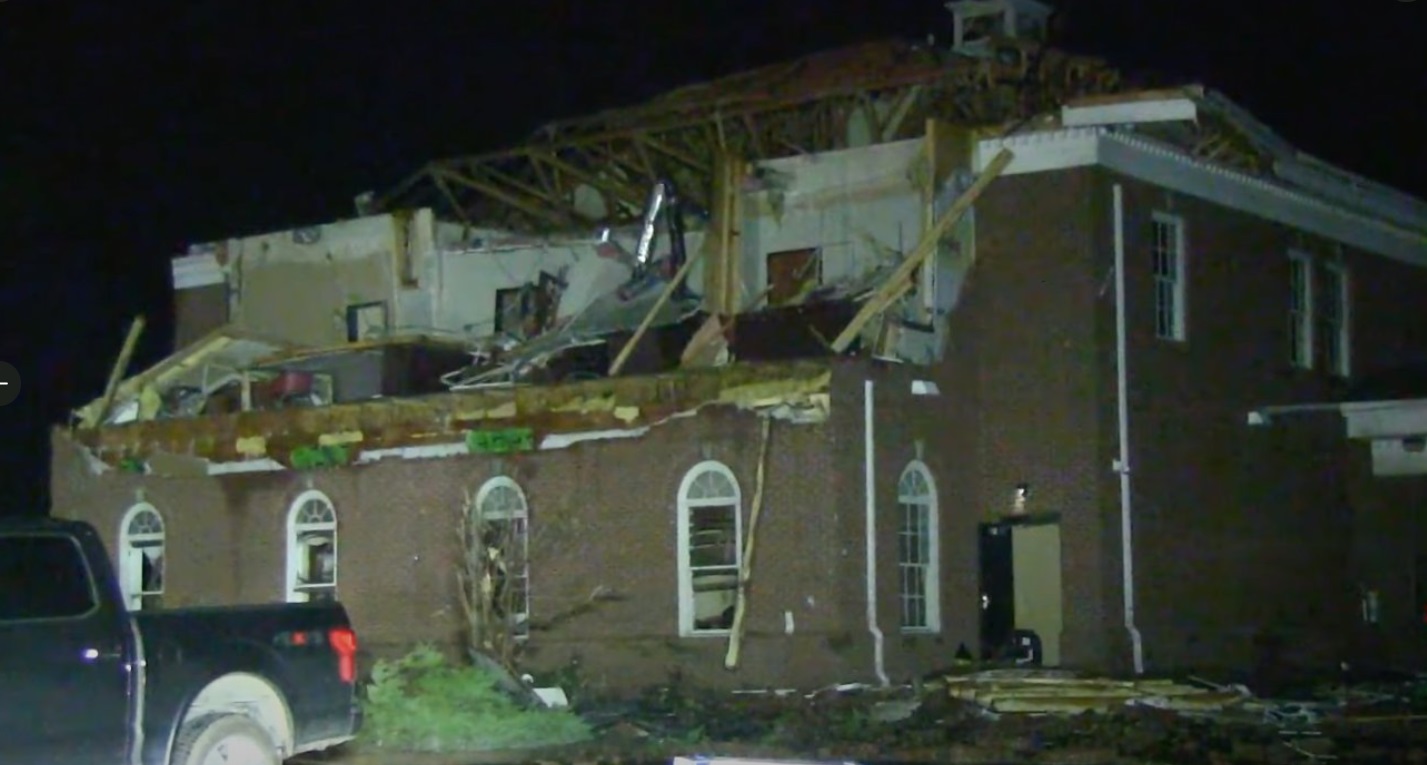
474;475;531;638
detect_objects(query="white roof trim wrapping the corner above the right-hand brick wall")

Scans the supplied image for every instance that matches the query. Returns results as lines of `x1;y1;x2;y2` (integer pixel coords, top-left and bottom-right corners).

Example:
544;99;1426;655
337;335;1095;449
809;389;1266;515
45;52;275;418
976;127;1427;267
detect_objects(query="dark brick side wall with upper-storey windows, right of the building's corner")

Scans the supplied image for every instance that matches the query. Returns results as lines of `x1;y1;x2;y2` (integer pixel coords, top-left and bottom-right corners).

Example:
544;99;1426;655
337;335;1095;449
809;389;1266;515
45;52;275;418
1090;173;1427;668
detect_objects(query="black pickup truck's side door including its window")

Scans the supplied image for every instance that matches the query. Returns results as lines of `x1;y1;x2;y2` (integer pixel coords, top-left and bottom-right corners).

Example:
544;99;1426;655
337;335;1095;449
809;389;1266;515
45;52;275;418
0;534;128;765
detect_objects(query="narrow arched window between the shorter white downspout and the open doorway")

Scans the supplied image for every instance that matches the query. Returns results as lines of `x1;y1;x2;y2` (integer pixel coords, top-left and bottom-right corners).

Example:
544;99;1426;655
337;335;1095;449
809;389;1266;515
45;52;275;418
896;461;942;632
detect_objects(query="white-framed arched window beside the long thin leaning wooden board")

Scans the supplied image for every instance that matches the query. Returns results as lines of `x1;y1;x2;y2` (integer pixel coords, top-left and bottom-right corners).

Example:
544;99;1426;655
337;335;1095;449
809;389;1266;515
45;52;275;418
679;461;743;635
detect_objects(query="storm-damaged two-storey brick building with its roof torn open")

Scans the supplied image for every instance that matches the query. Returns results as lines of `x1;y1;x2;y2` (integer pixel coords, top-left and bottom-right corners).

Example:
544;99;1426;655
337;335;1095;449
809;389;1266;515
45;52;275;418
44;1;1427;687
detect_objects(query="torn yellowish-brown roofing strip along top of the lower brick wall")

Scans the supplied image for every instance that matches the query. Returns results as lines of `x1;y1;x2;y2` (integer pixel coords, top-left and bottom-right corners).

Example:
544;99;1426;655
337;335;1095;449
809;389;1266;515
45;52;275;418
73;360;832;470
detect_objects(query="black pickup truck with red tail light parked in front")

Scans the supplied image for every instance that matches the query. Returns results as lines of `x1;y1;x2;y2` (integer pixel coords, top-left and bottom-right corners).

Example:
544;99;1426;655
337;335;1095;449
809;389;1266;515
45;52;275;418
0;518;361;765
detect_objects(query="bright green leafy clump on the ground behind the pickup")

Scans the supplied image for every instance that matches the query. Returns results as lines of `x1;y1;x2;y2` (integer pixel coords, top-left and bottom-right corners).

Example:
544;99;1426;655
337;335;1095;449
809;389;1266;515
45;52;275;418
362;647;591;752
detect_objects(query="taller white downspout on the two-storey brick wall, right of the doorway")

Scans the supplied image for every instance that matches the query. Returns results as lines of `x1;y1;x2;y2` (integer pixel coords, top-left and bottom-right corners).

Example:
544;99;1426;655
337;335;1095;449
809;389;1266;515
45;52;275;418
1114;184;1144;675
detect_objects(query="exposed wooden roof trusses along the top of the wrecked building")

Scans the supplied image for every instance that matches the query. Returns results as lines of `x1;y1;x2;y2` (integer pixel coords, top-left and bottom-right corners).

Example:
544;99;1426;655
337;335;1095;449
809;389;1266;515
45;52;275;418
377;39;1124;230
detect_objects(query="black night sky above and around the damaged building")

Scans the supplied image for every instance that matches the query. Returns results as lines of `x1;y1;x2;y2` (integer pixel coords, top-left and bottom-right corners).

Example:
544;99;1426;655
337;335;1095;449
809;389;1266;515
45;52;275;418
0;0;1427;512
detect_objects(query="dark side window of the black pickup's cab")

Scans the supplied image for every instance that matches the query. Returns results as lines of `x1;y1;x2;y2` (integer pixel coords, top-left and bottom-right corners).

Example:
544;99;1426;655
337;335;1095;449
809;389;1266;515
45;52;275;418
0;535;96;622
